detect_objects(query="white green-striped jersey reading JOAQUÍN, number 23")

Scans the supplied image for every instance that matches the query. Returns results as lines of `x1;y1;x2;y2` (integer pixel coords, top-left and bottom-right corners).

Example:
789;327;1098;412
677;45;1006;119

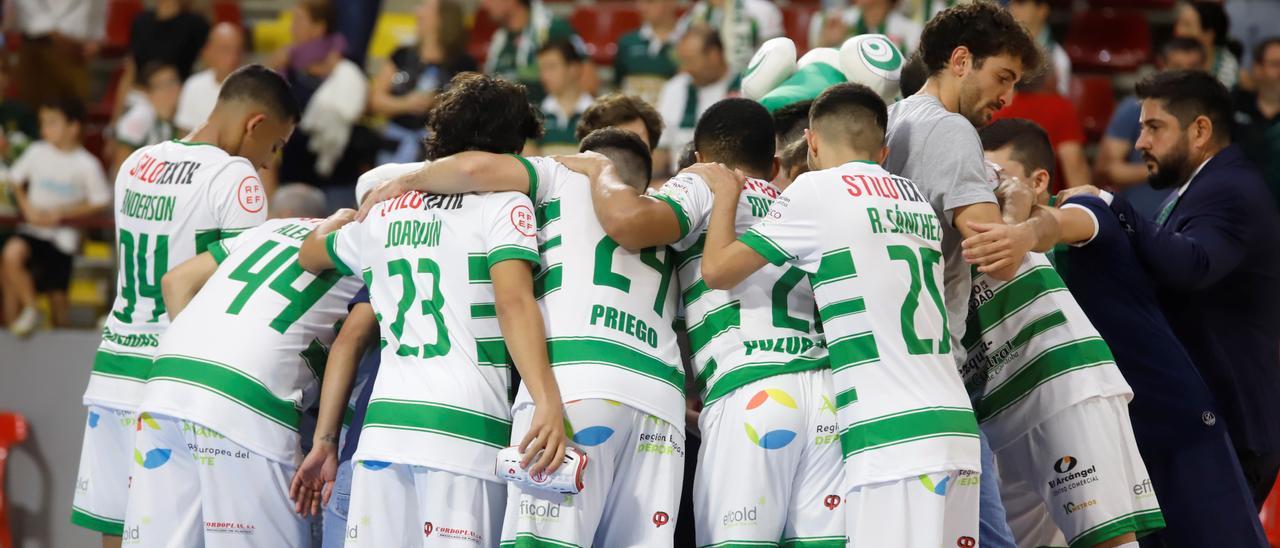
326;192;538;481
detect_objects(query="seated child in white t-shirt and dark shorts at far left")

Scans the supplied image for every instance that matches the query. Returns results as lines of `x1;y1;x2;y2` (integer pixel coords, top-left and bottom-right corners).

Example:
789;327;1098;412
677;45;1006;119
0;99;111;337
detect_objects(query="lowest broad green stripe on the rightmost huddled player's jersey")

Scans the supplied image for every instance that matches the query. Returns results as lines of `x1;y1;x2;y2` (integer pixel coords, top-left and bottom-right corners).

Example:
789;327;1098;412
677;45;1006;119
974;337;1115;421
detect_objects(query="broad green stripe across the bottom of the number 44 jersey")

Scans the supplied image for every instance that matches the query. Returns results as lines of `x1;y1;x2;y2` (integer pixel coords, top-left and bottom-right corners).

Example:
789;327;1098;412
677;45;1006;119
147;356;300;431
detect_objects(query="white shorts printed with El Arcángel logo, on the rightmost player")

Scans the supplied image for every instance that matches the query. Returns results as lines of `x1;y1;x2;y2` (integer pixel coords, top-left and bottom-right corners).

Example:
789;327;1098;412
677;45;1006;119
996;397;1165;547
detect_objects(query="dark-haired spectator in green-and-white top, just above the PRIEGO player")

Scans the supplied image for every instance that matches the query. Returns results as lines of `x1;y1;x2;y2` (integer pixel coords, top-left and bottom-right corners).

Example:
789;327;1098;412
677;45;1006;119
532;40;591;155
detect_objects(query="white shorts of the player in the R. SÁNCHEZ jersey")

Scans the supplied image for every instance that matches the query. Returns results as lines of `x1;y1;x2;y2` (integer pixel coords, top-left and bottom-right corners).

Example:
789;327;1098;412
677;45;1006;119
845;470;980;548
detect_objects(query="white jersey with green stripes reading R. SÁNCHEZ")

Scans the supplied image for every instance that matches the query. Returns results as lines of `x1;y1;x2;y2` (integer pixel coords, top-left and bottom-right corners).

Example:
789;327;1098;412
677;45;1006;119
740;161;979;487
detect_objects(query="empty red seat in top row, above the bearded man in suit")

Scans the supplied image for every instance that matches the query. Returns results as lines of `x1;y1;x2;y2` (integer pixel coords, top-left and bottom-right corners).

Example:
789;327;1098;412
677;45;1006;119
1064;9;1151;72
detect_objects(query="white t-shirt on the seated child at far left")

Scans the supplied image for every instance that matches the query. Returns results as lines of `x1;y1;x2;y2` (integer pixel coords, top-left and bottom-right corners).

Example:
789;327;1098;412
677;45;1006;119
9;141;111;255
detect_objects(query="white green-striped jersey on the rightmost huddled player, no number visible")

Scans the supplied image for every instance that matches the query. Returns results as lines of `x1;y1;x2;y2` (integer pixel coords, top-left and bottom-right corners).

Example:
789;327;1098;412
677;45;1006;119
960;254;1133;449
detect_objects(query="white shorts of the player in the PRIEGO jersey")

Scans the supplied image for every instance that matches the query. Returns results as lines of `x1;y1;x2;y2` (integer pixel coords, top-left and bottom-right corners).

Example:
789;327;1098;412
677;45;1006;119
502;399;685;548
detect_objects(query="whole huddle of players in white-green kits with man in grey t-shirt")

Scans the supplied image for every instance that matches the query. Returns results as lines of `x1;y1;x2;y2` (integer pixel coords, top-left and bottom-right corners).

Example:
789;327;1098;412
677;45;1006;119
64;3;1264;548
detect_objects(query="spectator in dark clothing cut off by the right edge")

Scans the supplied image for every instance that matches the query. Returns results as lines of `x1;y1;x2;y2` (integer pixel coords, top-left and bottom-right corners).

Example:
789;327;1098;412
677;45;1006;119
1231;36;1280;204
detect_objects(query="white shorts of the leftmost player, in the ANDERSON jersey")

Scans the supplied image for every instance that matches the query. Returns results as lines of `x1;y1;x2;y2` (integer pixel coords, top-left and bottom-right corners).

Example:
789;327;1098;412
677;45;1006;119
72;405;137;536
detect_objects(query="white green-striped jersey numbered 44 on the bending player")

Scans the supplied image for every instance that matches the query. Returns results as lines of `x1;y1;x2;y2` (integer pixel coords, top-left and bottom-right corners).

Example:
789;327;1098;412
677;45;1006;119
138;219;361;463
